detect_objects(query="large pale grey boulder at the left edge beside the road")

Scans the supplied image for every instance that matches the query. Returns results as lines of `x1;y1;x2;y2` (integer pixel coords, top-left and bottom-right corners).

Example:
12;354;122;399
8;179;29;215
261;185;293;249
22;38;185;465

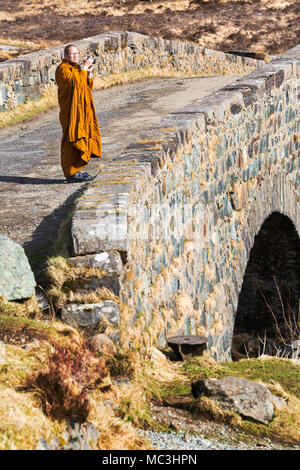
0;235;36;300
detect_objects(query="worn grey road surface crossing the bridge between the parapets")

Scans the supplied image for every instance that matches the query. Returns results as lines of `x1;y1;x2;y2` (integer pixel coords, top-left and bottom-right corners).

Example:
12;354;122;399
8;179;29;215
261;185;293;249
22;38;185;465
0;75;241;270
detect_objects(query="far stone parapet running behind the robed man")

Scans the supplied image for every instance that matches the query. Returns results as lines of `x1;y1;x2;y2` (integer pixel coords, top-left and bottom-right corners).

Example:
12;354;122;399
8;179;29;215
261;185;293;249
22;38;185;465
0;32;263;111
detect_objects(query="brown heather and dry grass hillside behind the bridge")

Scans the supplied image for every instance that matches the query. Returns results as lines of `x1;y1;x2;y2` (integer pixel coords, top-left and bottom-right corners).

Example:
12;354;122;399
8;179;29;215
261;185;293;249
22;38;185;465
0;0;300;60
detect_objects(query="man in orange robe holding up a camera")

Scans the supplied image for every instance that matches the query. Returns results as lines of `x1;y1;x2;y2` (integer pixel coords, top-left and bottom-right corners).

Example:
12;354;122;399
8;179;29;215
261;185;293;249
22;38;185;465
55;44;101;183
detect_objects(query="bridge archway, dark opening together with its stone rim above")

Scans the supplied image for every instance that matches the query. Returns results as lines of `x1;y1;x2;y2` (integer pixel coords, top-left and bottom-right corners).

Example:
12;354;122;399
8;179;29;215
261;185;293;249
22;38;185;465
227;173;300;359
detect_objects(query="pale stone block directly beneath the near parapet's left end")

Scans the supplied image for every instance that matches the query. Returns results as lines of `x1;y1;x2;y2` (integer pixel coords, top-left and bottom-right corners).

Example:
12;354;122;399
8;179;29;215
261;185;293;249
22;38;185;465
68;251;124;276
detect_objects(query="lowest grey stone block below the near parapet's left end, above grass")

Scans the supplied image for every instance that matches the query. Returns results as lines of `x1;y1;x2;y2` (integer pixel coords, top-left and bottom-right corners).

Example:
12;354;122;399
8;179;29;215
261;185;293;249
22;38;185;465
61;300;120;332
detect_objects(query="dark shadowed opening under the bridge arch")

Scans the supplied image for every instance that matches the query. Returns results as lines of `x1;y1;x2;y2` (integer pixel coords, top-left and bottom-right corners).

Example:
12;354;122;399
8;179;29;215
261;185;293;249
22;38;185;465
232;212;300;360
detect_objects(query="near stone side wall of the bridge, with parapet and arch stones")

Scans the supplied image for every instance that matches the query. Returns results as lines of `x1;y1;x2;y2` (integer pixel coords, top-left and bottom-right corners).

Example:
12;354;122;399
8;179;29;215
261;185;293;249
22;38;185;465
72;46;300;360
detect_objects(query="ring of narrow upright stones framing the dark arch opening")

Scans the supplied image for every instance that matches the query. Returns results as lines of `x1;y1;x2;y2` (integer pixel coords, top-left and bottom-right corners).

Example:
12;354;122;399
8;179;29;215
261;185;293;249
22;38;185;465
211;171;300;360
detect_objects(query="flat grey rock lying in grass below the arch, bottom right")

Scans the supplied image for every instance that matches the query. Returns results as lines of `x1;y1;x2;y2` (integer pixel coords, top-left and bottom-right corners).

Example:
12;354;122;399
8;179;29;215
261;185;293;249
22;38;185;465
192;377;285;424
